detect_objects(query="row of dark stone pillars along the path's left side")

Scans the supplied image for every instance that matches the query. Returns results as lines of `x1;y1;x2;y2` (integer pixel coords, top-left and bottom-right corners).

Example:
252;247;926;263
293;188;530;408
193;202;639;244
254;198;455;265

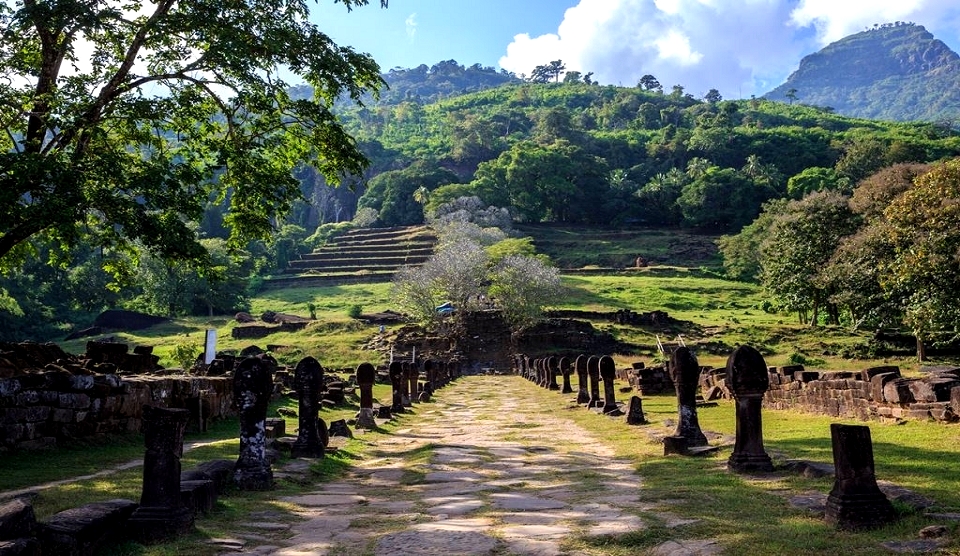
129;355;460;543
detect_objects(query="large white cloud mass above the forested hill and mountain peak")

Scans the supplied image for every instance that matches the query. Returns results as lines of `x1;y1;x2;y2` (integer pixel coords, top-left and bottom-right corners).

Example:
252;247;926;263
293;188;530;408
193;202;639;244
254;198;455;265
500;0;960;98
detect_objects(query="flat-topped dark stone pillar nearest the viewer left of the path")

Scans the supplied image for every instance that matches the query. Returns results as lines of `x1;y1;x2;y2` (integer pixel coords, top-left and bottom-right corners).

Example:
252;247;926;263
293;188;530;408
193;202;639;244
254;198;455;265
127;405;194;544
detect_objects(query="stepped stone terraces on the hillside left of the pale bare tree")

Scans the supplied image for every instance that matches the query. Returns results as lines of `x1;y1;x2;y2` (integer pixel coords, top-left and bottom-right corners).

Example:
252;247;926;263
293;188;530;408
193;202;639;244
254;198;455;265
266;226;437;288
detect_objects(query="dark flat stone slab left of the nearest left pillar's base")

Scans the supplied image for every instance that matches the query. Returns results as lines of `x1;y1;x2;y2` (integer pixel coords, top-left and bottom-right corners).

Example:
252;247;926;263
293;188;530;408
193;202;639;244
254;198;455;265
37;499;139;556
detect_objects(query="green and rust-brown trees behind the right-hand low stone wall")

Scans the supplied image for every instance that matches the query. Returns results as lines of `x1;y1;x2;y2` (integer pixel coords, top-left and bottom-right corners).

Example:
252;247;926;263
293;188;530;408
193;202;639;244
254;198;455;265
719;158;960;359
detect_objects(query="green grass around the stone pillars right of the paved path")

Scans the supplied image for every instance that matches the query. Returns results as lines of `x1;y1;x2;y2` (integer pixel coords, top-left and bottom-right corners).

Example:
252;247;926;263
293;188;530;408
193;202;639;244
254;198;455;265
518;376;960;556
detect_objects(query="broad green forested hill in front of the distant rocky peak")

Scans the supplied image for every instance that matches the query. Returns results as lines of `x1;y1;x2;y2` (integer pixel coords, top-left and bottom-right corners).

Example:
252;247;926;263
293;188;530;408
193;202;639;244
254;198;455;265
300;78;960;231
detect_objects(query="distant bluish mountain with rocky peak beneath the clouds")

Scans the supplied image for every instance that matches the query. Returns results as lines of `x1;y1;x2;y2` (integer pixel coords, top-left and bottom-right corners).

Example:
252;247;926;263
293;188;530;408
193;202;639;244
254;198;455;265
765;22;960;121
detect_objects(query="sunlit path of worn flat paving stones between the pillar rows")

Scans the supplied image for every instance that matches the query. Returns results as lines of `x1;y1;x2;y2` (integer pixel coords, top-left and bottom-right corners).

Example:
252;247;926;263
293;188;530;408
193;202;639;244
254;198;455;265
224;376;719;556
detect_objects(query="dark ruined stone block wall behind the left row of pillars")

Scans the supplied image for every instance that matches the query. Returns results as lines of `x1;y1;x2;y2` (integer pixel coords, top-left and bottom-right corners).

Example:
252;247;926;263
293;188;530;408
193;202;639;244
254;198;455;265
0;342;233;450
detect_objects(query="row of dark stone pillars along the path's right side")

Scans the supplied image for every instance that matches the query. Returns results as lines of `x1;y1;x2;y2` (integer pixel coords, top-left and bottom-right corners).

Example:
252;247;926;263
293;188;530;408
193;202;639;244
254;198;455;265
514;346;895;529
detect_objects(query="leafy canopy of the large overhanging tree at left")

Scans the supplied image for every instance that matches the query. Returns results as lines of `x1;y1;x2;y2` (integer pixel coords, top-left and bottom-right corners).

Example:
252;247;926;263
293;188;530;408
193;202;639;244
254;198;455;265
0;0;387;270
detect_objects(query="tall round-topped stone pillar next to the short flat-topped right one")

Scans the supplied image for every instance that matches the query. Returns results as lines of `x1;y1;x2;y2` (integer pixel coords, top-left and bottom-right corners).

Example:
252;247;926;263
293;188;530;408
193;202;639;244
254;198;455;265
727;346;773;473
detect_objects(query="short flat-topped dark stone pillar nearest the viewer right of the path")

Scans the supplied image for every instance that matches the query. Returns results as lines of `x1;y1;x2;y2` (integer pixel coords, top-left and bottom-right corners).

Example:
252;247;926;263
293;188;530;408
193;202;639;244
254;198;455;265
824;423;896;530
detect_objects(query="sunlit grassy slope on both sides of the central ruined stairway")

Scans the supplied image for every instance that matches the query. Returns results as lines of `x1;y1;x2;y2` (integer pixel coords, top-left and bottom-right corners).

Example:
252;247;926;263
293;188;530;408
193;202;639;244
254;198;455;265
56;267;948;373
